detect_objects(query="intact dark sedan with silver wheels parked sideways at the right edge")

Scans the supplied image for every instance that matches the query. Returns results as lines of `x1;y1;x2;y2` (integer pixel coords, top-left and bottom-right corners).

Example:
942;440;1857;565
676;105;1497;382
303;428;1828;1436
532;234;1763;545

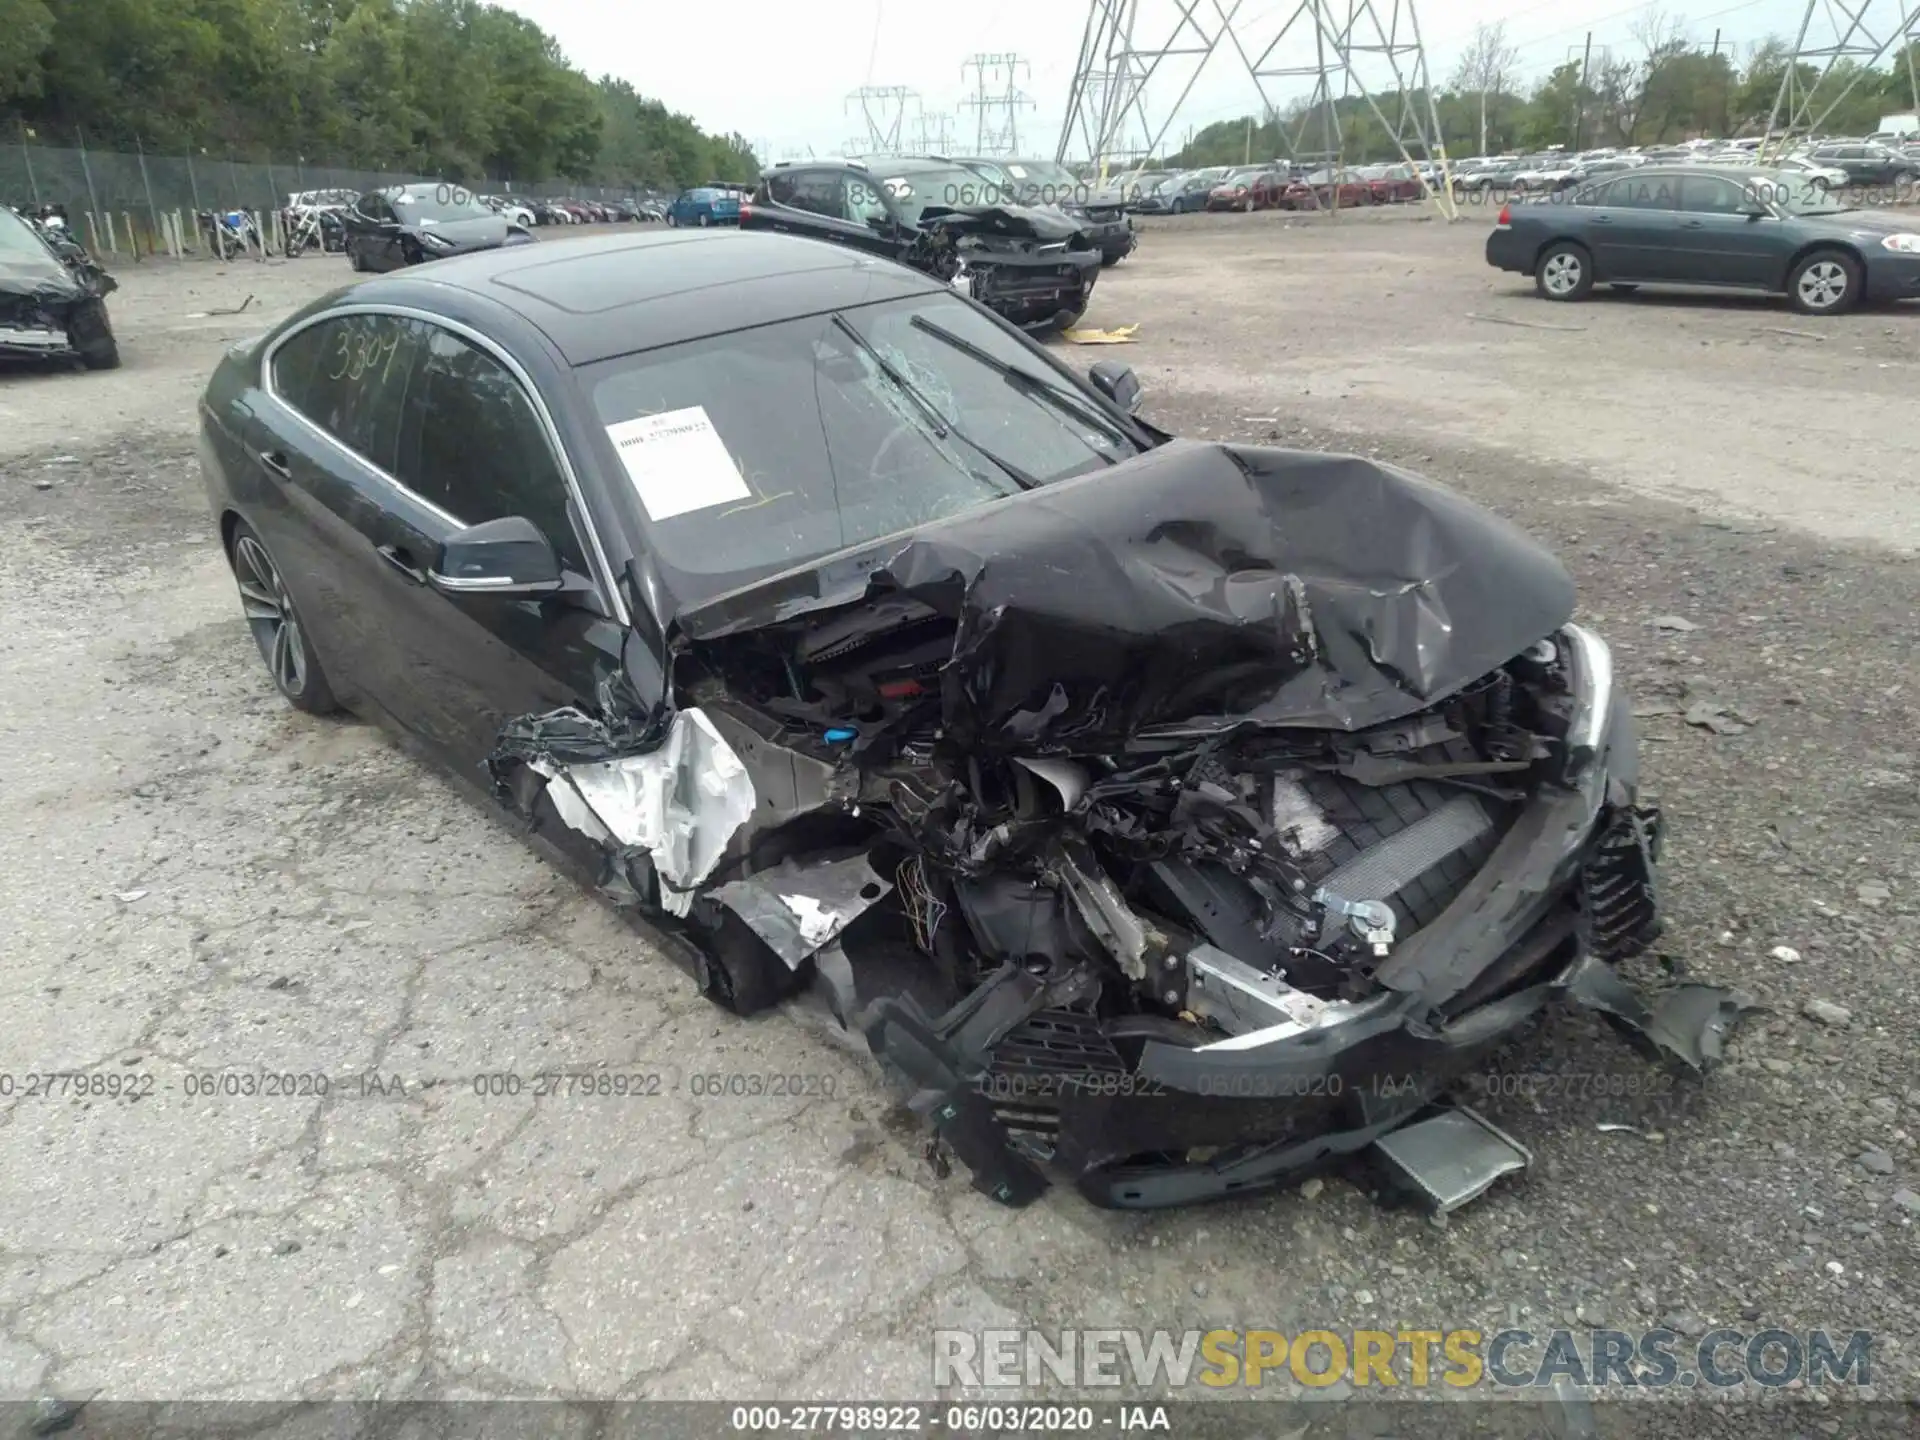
1486;163;1920;315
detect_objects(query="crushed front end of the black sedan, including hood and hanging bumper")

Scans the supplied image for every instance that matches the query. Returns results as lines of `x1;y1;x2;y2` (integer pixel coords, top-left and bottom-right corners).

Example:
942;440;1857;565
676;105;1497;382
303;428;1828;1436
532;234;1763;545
495;442;1745;1208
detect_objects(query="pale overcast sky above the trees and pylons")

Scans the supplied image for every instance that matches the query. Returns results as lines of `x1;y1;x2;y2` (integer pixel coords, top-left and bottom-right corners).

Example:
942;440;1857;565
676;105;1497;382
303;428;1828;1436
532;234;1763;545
503;0;1812;159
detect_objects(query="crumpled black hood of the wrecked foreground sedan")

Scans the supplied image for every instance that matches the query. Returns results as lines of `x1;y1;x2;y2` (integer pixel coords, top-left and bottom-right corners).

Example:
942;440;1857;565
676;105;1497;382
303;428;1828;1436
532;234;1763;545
680;442;1574;751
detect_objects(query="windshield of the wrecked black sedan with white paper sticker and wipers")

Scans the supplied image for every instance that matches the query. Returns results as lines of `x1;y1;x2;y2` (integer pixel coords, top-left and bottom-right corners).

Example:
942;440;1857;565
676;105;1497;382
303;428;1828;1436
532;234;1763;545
584;294;1139;593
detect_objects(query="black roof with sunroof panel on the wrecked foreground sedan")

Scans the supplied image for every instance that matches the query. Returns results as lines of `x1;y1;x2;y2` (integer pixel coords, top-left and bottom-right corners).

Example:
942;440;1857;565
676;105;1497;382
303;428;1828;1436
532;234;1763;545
348;227;945;369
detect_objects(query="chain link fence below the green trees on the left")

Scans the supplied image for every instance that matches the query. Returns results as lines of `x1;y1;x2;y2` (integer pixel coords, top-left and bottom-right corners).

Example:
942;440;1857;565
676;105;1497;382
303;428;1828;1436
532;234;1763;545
0;138;660;257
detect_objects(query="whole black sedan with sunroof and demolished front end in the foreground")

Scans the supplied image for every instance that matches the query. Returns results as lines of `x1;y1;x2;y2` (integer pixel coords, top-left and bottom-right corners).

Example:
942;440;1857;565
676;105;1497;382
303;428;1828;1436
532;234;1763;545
202;230;1741;1208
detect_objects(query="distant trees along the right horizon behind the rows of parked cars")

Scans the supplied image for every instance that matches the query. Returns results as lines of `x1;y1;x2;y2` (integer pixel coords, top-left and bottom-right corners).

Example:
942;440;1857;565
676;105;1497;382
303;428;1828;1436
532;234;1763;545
1169;17;1920;167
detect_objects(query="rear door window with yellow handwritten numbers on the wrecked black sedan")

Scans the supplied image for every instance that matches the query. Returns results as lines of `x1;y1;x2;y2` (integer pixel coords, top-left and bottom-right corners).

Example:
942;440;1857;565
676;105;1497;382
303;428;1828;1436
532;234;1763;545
273;315;417;470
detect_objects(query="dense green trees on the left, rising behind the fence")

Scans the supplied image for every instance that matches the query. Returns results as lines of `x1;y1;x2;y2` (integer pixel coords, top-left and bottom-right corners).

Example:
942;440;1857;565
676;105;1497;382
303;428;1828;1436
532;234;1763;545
0;0;758;188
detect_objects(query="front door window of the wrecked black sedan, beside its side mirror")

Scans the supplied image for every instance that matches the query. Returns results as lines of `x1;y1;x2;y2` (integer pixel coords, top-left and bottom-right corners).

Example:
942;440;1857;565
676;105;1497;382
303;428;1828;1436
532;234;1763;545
394;321;591;574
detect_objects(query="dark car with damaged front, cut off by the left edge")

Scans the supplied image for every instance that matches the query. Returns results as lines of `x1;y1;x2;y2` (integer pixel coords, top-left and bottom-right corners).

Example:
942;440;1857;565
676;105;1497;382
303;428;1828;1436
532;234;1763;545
0;205;119;371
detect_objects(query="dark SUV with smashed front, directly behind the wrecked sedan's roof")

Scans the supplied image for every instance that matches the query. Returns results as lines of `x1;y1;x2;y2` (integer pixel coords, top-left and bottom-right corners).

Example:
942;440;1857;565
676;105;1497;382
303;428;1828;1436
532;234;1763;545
739;157;1102;330
